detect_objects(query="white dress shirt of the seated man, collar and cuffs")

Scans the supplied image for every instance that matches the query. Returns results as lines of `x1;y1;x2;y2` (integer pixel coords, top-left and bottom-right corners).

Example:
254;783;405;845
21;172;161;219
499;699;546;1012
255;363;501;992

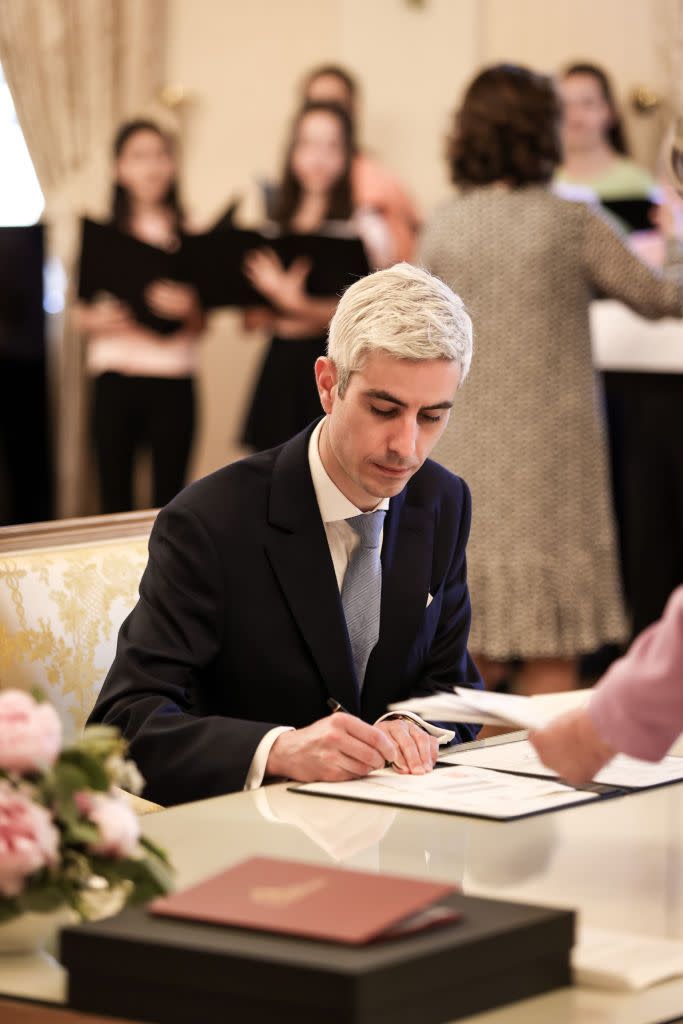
245;420;455;790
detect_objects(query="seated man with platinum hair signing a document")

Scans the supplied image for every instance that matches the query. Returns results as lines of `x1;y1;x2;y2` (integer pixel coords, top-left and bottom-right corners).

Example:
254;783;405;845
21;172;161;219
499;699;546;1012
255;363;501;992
90;263;481;804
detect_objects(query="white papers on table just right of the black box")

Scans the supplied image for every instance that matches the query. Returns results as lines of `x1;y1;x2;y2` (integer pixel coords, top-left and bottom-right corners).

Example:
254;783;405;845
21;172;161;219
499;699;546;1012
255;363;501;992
571;927;683;991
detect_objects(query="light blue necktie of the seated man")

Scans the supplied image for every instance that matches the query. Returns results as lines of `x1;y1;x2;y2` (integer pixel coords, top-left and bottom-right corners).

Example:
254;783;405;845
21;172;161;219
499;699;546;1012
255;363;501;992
341;509;386;690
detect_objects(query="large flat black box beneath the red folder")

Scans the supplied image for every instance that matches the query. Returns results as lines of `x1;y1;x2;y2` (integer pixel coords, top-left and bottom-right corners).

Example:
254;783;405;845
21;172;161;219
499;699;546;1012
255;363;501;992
60;894;574;1024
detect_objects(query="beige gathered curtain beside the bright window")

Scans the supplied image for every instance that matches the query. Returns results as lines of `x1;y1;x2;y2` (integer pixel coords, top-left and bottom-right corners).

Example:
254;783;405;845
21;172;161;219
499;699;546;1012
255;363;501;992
0;0;167;515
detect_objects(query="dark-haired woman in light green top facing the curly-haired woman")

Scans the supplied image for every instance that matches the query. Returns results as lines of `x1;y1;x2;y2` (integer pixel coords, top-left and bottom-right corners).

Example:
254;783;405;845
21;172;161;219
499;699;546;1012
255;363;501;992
555;63;655;229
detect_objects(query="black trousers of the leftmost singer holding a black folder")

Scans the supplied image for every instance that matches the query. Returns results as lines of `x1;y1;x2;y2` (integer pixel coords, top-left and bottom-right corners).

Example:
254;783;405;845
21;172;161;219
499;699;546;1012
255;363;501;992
92;373;196;513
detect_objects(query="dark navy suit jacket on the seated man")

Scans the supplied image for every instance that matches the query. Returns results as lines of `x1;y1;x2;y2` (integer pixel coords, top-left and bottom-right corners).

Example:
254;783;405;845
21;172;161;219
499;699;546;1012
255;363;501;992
90;426;480;804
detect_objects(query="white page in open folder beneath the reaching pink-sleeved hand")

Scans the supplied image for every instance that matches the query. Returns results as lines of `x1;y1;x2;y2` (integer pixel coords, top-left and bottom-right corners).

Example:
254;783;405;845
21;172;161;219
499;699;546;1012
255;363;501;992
439;739;683;790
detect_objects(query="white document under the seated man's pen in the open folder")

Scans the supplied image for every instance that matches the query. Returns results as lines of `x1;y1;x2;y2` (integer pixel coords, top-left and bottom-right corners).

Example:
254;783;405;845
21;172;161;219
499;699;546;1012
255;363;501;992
293;765;597;819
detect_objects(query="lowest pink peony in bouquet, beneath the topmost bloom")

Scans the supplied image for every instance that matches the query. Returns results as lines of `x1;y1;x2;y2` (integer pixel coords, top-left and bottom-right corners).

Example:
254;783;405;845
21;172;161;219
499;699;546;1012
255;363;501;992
0;780;59;897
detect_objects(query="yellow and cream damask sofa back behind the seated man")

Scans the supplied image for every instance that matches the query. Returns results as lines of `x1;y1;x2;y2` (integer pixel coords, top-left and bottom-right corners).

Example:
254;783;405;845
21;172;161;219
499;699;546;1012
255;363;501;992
0;511;157;813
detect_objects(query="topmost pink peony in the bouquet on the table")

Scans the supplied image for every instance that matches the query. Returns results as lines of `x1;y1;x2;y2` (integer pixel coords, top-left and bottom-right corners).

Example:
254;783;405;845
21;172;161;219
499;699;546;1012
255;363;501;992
0;690;61;772
